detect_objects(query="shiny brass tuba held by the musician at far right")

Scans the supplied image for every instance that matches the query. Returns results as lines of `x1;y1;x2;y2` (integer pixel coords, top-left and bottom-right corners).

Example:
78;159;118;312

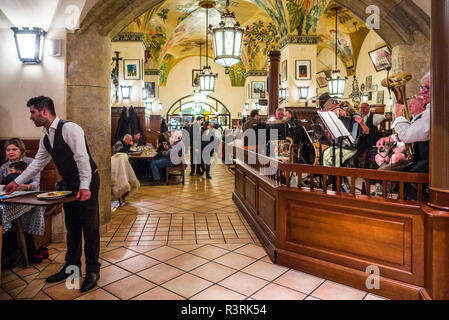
381;73;413;161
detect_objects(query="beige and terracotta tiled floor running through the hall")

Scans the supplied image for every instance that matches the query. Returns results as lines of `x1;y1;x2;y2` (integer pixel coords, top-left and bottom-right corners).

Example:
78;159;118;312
0;165;382;300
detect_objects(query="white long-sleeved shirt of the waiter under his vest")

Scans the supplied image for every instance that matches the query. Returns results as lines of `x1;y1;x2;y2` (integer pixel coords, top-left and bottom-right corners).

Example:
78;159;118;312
15;117;92;190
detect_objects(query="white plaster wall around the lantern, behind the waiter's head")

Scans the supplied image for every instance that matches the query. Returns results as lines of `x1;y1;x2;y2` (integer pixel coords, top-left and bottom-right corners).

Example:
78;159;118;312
0;21;66;139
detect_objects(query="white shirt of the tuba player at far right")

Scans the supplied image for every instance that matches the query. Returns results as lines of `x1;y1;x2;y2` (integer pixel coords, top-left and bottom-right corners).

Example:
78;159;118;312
392;109;430;143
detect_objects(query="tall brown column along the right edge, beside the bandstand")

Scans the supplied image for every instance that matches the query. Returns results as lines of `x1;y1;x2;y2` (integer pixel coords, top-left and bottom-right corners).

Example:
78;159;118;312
423;0;449;300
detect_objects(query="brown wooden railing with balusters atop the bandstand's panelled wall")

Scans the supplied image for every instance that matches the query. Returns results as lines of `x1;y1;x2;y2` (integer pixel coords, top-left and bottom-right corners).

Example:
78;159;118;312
235;147;429;202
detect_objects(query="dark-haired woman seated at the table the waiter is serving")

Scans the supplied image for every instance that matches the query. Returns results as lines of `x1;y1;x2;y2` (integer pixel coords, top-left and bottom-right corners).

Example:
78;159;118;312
0;138;48;263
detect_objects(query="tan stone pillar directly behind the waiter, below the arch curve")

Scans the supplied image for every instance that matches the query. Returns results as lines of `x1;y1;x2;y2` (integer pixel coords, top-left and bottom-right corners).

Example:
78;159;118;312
66;28;111;230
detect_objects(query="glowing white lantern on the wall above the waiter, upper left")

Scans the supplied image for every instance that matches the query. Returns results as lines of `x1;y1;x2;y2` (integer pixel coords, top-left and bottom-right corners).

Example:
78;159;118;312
11;27;45;64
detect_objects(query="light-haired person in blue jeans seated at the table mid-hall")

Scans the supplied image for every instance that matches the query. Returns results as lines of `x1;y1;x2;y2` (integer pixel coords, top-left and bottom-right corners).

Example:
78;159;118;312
150;131;184;184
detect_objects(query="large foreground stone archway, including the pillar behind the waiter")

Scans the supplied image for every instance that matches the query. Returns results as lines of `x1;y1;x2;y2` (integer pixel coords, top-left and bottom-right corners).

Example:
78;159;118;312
66;0;430;225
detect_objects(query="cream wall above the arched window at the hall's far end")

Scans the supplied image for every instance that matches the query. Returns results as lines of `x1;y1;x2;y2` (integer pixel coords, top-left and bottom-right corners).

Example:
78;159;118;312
159;57;245;119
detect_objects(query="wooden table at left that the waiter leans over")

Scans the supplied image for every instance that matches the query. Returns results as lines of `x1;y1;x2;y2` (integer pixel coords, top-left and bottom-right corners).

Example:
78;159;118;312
0;192;77;267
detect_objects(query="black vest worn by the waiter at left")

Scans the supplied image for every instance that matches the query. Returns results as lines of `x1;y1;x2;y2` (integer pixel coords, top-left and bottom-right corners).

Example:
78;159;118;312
44;120;97;191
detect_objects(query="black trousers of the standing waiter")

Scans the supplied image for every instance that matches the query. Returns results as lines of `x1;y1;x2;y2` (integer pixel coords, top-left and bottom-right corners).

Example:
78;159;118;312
63;172;100;273
